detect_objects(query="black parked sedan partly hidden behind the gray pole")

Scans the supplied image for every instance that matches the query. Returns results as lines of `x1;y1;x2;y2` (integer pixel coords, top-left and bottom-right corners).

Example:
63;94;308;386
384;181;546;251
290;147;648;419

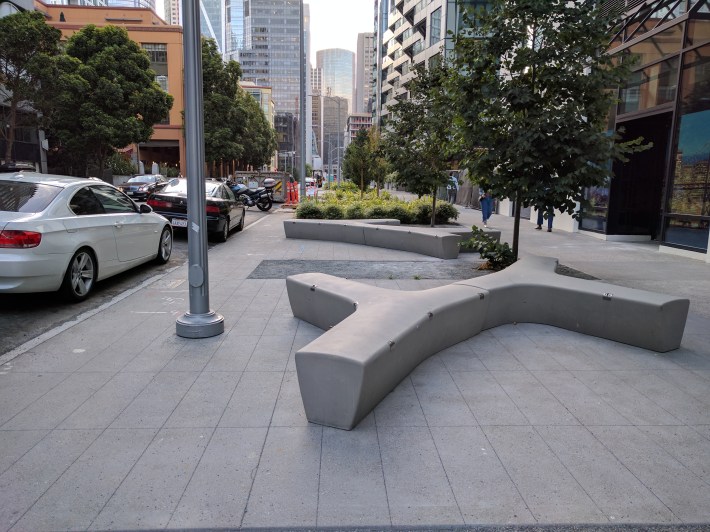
148;178;246;242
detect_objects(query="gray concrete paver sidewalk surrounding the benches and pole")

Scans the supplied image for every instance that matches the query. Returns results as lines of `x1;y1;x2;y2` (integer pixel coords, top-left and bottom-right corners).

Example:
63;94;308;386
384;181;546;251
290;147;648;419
0;209;710;531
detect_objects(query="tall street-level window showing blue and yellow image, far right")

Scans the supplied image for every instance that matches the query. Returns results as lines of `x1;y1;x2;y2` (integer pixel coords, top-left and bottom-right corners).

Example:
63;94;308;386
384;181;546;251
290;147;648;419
665;45;710;249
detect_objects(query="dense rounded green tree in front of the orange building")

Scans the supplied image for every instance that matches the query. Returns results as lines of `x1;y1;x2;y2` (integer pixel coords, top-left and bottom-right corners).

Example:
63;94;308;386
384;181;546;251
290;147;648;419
52;25;173;176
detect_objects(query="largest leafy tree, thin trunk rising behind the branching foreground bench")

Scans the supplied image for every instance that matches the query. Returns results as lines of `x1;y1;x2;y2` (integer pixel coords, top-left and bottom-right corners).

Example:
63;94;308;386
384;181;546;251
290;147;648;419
449;0;647;259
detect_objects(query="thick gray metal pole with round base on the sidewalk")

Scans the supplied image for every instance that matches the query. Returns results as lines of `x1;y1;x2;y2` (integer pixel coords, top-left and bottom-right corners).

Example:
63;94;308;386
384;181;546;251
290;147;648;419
175;0;224;338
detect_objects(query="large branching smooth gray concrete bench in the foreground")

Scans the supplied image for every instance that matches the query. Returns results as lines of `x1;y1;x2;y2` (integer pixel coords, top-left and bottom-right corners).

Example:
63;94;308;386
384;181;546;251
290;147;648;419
286;257;690;430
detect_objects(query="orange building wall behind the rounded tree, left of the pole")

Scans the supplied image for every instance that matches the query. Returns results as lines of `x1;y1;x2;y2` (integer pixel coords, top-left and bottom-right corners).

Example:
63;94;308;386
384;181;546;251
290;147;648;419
35;0;186;175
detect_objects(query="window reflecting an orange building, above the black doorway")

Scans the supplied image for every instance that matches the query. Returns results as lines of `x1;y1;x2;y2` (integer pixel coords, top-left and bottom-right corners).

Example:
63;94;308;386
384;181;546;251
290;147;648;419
619;57;678;115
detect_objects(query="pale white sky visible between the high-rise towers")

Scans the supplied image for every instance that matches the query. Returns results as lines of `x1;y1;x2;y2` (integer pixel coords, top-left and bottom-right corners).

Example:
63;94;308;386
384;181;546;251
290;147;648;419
156;0;375;66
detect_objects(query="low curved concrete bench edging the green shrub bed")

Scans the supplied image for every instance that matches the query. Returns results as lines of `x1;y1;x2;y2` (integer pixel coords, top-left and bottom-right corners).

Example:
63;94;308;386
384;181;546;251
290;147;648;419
284;219;500;259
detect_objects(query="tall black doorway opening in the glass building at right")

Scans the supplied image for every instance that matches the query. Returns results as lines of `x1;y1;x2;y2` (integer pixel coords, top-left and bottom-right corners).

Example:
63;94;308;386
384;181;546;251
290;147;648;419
607;112;672;240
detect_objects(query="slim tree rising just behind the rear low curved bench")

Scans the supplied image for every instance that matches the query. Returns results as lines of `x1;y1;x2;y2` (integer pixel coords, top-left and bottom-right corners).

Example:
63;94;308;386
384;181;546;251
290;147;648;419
382;64;454;227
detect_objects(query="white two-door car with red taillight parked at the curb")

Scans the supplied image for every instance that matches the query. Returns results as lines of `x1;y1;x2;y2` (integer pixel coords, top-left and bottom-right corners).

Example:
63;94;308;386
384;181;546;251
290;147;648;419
0;172;173;301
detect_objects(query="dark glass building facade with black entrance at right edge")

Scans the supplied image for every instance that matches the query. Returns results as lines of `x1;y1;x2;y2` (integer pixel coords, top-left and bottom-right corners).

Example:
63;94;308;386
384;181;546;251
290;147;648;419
581;0;710;253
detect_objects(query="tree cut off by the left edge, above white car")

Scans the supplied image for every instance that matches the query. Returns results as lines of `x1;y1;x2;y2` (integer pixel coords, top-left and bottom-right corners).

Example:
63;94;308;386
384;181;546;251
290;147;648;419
0;11;61;162
